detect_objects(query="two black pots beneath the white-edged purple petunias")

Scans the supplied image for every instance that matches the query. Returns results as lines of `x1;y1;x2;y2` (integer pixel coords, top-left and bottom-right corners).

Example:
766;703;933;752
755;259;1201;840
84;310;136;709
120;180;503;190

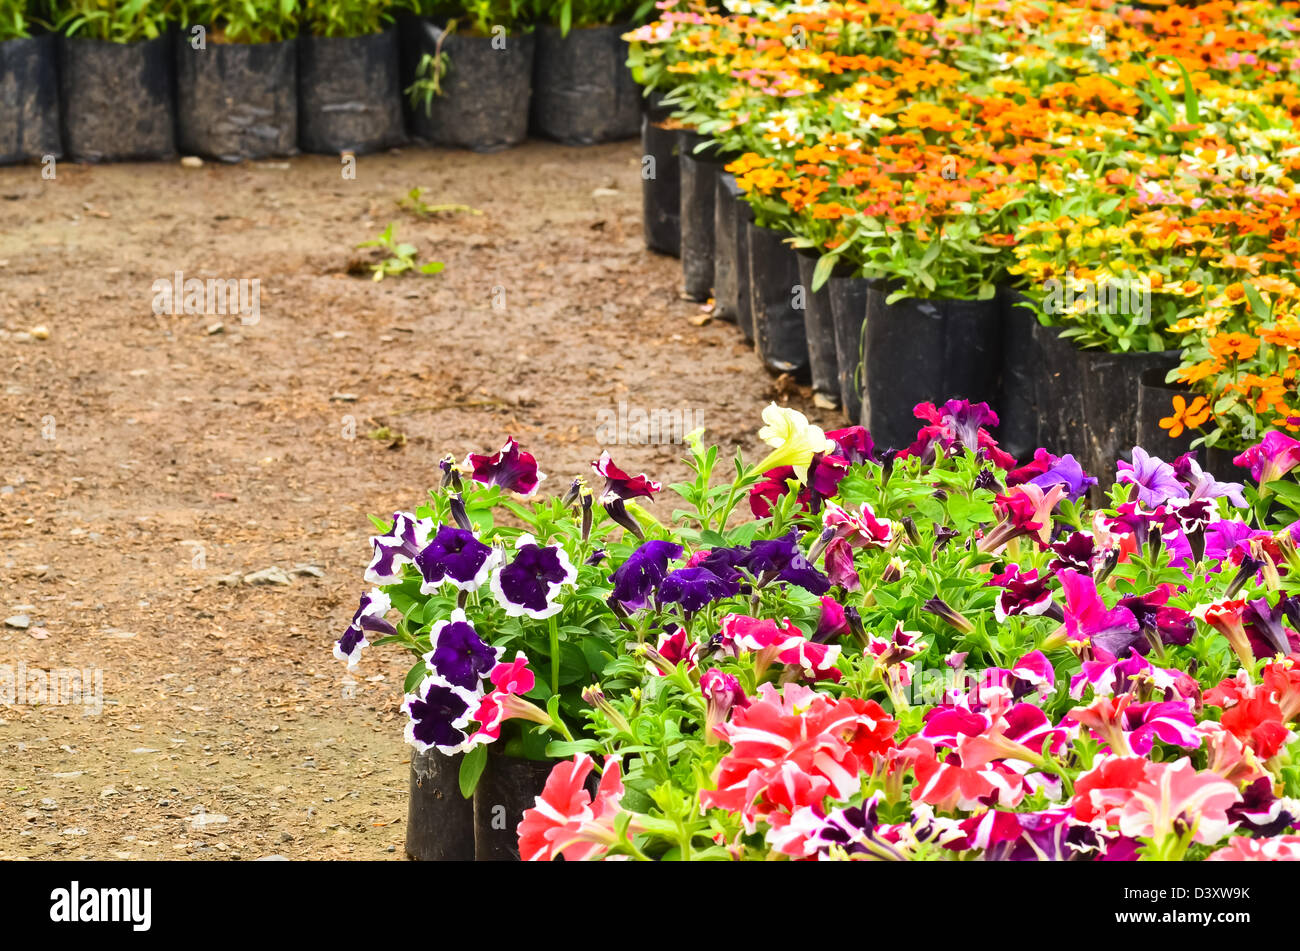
406;747;597;861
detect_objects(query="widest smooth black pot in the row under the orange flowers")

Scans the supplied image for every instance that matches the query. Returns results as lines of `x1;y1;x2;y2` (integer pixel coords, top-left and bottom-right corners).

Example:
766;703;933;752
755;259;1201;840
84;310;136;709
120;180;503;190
862;287;1002;448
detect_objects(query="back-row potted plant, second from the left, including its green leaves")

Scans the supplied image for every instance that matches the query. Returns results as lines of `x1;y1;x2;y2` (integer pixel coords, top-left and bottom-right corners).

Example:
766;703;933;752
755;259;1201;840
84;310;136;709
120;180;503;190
48;0;176;162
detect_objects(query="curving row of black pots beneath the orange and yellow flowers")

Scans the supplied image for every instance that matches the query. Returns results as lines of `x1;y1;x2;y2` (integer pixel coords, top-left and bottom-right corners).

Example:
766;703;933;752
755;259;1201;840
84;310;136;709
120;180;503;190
642;142;1206;475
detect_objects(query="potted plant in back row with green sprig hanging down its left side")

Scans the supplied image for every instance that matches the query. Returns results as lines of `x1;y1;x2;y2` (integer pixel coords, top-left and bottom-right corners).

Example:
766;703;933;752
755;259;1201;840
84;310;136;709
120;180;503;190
407;0;534;152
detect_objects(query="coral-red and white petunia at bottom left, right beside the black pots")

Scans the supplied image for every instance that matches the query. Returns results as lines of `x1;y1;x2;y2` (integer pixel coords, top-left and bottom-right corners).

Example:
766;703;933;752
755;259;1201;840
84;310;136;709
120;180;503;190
517;754;632;861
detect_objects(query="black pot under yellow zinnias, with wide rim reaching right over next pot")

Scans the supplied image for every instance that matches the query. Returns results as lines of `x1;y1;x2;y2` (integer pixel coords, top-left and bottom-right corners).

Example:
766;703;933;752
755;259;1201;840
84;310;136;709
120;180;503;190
1079;351;1179;488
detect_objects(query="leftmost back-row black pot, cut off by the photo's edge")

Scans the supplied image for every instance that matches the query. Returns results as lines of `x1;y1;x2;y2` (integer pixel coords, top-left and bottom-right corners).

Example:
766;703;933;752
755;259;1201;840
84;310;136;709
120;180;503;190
0;34;62;165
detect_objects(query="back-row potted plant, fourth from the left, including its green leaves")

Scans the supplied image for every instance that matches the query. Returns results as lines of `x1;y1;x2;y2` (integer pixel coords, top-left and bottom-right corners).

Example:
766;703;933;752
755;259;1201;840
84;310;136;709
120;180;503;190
298;0;404;153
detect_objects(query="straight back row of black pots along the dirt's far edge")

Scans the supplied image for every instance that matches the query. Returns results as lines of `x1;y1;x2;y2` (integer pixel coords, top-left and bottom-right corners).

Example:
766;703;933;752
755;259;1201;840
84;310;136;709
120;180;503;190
0;18;641;164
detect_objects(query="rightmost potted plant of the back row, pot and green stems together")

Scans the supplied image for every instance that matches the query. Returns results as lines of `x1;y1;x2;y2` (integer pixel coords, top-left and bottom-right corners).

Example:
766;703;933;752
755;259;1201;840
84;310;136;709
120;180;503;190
530;0;650;146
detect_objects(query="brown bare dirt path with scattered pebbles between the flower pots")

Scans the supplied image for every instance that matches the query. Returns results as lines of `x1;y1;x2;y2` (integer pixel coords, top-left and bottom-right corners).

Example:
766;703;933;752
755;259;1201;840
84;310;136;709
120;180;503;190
0;143;836;859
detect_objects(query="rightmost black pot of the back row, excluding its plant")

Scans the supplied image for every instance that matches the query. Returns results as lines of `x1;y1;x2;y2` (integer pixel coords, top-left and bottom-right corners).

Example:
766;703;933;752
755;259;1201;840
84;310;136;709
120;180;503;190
530;25;641;146
